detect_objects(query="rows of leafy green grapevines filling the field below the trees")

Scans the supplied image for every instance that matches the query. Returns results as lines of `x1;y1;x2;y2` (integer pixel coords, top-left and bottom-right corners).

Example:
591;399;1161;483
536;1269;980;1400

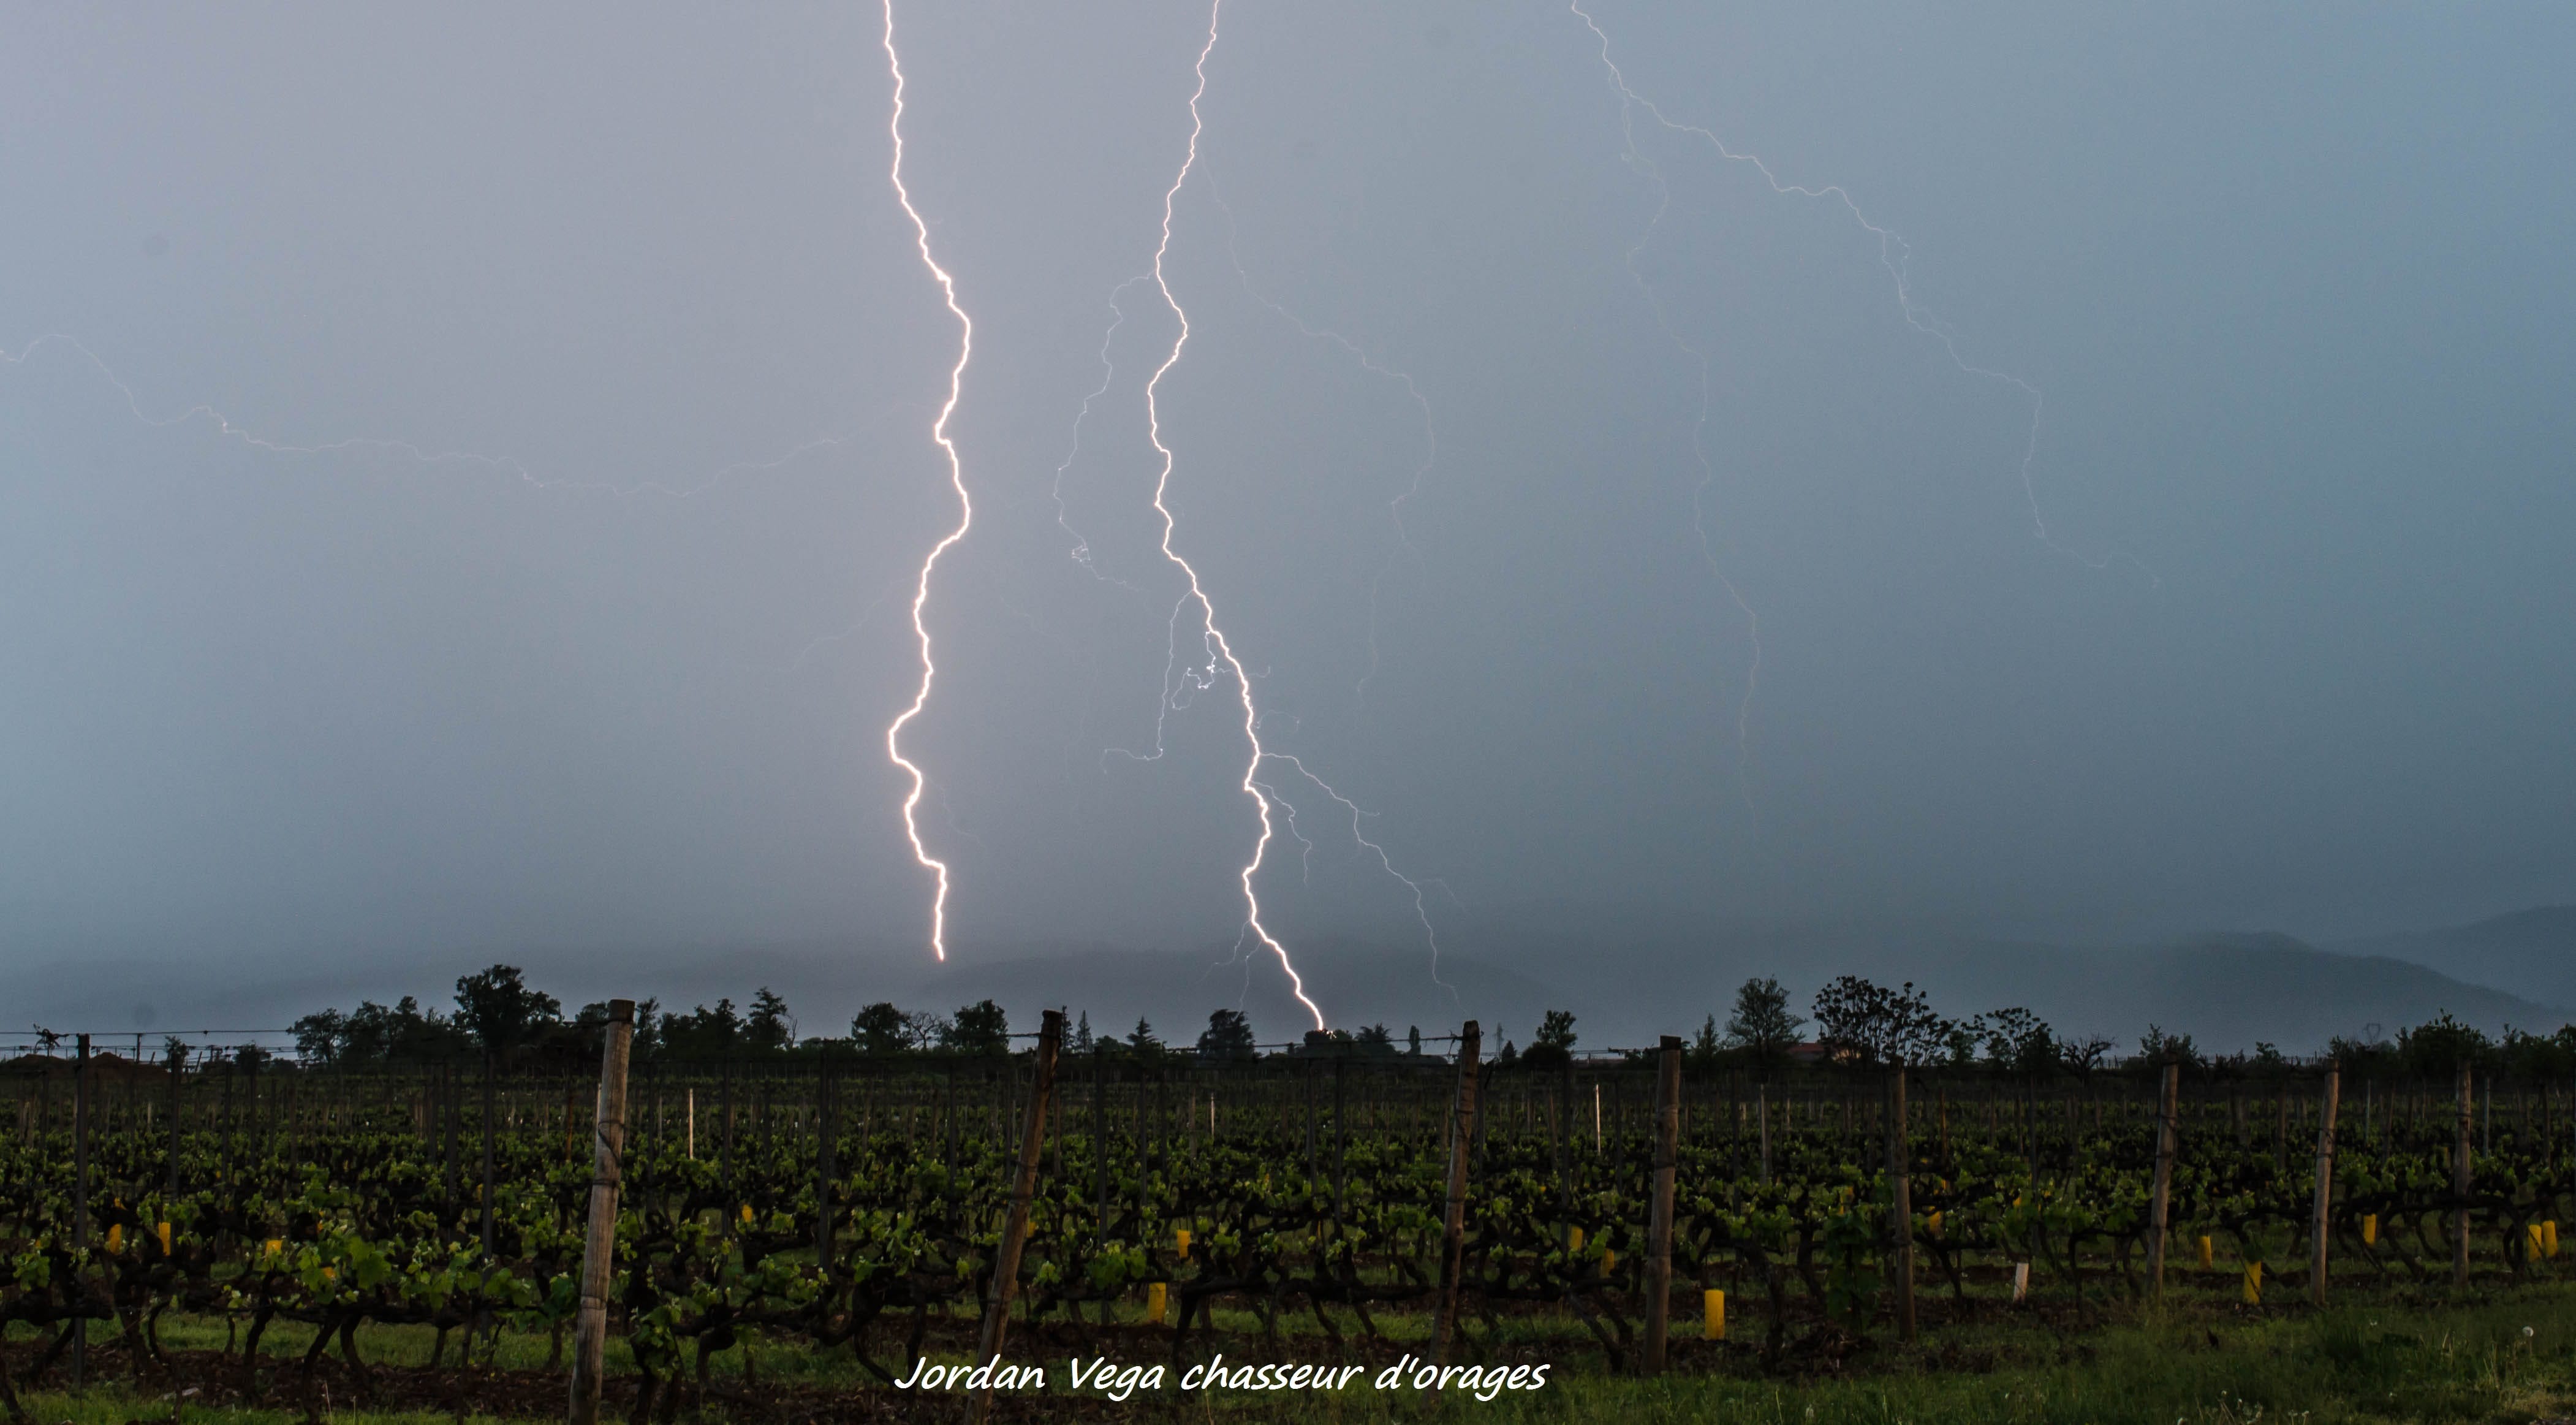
0;1000;2576;1420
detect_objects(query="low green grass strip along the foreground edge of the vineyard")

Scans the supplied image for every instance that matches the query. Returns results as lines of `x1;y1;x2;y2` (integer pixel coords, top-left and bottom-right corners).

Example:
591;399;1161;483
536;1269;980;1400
23;1286;2576;1425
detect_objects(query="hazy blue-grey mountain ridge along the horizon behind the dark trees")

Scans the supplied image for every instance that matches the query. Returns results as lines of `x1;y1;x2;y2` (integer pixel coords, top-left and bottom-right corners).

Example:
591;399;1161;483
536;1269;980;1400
0;907;2576;1054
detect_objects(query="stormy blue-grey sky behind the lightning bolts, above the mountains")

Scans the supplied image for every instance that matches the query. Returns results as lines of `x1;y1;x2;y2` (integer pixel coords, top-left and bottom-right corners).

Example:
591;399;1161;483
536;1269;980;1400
0;0;2576;1020
